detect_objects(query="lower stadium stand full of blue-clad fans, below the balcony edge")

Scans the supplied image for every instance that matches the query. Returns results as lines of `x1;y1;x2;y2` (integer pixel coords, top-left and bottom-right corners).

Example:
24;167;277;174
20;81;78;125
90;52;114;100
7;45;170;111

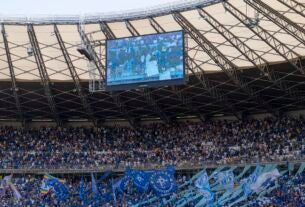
0;163;305;207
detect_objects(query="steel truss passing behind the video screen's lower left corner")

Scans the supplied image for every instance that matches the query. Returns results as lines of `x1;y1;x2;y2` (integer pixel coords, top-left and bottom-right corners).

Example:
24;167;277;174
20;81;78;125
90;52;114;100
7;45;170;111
78;23;136;128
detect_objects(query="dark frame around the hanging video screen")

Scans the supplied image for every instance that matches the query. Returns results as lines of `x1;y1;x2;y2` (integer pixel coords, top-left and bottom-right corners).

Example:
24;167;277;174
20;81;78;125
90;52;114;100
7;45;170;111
105;30;186;91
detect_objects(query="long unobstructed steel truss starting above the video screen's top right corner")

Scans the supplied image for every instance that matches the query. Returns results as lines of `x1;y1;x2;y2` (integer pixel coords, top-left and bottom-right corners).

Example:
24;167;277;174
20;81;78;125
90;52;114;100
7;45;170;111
173;12;276;115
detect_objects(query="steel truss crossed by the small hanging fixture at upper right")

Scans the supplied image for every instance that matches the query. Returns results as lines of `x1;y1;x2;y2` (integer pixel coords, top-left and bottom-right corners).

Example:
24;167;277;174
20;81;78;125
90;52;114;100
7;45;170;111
226;2;305;74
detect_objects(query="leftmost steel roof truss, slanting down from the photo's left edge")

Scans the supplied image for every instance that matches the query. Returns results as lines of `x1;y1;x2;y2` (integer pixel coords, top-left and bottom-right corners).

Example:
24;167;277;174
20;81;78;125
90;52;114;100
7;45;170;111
1;24;25;125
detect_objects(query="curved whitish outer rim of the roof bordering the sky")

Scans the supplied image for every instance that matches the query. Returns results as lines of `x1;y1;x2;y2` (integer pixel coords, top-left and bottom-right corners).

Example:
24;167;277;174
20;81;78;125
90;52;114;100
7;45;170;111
0;0;224;25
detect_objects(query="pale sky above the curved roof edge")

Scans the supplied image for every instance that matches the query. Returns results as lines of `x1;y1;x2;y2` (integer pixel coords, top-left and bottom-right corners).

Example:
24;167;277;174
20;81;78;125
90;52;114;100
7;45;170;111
0;0;177;17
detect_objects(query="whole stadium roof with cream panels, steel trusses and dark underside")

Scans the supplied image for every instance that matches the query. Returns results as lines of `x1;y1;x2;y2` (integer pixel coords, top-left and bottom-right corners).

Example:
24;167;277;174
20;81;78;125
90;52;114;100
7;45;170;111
0;0;305;125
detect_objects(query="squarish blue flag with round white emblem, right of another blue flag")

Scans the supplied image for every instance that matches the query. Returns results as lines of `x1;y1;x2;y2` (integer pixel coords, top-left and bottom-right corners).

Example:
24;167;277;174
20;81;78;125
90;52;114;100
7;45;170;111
150;169;177;197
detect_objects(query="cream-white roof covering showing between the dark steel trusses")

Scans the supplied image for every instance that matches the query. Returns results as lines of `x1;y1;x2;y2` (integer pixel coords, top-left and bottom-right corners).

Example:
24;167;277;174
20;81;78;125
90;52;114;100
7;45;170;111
0;0;305;81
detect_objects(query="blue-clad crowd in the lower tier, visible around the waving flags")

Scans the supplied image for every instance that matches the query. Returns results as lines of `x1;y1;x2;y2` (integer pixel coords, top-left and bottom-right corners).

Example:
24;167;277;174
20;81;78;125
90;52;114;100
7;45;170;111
0;172;305;207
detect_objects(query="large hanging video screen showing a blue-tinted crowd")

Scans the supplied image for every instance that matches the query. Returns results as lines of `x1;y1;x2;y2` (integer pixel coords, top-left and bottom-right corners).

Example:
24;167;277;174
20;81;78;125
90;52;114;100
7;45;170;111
106;31;185;90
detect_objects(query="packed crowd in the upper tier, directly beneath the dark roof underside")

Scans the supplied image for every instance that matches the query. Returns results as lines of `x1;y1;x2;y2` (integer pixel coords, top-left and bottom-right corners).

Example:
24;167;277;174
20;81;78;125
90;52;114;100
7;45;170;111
0;117;305;169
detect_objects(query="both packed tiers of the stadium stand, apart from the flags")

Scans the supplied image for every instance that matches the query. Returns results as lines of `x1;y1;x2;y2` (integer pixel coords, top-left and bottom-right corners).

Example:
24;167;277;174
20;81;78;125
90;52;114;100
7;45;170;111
0;117;305;206
